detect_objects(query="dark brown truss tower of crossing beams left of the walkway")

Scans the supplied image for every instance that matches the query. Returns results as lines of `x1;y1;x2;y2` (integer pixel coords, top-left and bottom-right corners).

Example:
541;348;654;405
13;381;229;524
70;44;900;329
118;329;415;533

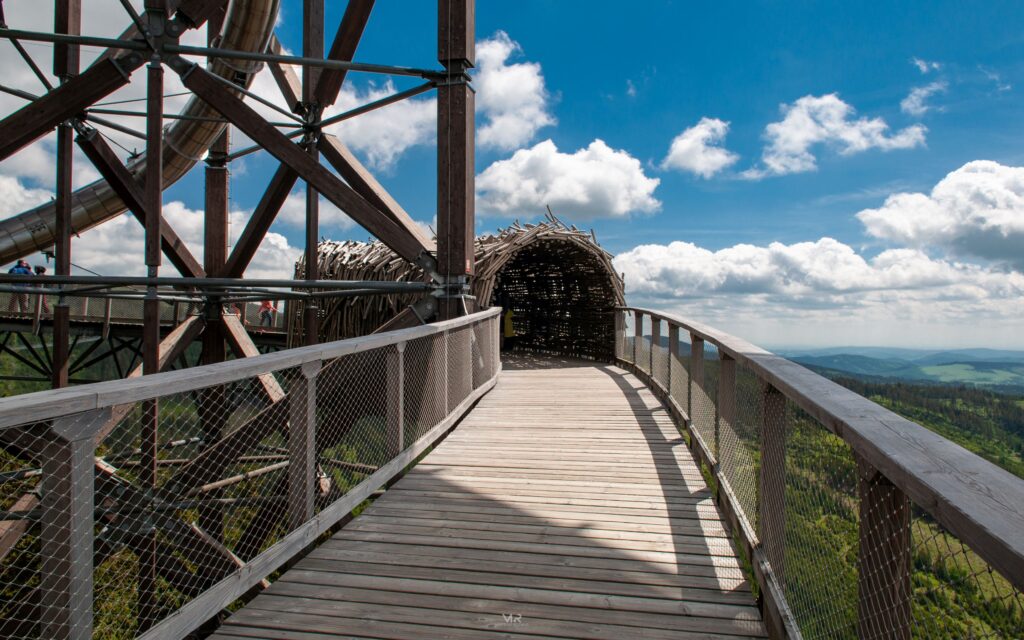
0;0;475;631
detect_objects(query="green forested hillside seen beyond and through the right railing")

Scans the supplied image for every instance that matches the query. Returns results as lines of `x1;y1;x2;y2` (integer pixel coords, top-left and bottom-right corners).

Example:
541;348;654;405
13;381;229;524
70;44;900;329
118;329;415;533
770;377;1024;640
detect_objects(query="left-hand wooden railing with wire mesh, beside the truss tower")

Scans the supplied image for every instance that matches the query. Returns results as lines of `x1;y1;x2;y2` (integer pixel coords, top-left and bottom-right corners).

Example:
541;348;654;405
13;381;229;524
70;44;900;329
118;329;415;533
0;309;501;640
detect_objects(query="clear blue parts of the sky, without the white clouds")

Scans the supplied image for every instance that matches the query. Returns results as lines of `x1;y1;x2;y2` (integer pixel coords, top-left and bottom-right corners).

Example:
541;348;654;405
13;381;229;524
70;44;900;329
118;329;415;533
157;0;1024;252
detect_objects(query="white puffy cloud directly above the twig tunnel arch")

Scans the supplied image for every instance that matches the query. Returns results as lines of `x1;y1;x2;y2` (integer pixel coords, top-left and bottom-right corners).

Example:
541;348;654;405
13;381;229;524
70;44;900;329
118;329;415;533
476;139;662;219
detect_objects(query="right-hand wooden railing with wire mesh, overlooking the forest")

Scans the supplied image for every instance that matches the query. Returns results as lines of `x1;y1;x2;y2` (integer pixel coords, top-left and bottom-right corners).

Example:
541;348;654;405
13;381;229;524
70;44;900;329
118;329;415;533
615;307;1024;640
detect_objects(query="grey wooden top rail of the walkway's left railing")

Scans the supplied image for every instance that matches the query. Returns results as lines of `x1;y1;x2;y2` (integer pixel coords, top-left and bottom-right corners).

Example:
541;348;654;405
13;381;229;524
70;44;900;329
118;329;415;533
0;307;501;430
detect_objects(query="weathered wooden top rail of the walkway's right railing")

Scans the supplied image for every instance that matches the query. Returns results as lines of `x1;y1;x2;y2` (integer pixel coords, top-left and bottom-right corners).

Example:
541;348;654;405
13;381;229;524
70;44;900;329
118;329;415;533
617;306;1024;589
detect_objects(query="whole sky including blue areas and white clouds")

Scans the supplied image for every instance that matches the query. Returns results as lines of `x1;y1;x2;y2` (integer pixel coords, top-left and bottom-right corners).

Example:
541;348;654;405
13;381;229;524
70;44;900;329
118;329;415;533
0;0;1024;347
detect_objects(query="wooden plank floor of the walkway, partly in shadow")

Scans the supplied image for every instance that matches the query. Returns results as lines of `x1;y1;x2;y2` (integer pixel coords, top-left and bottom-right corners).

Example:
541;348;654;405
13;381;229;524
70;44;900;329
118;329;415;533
214;359;765;640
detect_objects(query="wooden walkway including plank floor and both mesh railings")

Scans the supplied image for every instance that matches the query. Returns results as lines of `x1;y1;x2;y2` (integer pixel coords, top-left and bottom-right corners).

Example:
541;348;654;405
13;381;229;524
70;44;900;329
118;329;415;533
0;308;1024;640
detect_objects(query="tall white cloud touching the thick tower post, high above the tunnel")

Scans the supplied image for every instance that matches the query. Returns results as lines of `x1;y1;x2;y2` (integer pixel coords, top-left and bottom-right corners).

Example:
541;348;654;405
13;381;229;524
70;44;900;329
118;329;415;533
473;31;555;151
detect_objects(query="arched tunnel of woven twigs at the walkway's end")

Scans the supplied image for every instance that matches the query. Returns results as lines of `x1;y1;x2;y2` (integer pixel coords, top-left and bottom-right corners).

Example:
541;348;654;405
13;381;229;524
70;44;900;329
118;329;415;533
289;218;625;359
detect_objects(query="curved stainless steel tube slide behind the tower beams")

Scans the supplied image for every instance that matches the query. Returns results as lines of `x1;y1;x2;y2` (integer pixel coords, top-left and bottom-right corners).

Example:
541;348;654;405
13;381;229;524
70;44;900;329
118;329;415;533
0;0;279;264
